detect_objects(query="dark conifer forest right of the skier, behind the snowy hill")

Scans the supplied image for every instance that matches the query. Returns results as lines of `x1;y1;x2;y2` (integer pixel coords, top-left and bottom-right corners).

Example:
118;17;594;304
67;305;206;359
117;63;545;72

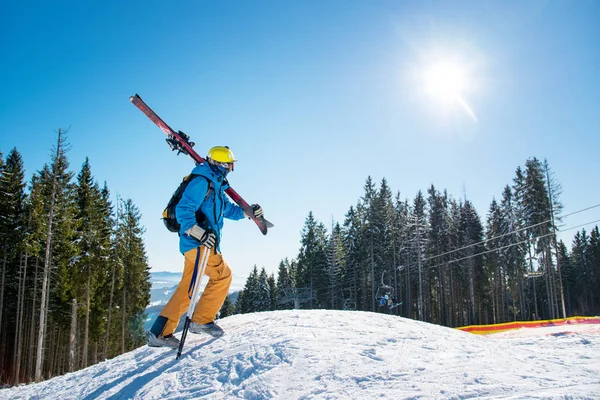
236;158;600;334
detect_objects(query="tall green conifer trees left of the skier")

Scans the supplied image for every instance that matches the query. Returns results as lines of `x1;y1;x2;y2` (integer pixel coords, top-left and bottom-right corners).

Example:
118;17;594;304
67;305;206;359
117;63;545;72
0;130;150;385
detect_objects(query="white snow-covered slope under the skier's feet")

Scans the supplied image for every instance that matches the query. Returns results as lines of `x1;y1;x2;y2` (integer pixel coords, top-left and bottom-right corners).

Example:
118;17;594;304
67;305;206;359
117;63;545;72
0;310;600;399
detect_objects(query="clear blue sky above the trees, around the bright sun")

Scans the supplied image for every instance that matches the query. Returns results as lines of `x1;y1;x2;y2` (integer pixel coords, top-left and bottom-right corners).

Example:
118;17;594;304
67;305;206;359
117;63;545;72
0;0;600;286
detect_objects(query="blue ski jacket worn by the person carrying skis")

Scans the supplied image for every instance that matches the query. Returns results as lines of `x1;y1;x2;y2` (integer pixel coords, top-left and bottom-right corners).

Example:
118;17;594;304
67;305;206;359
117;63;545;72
175;162;244;254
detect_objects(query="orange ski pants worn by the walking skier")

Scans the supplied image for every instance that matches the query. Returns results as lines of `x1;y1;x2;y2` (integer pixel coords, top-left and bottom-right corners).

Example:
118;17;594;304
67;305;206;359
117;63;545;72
160;247;231;336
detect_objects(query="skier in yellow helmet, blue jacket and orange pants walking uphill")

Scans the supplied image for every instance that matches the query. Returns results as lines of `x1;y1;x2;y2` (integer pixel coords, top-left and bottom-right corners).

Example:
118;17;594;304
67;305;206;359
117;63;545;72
146;146;263;348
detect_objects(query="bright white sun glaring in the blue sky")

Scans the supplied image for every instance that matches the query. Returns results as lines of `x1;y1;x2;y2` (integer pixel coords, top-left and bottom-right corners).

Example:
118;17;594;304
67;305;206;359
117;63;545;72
419;59;477;121
